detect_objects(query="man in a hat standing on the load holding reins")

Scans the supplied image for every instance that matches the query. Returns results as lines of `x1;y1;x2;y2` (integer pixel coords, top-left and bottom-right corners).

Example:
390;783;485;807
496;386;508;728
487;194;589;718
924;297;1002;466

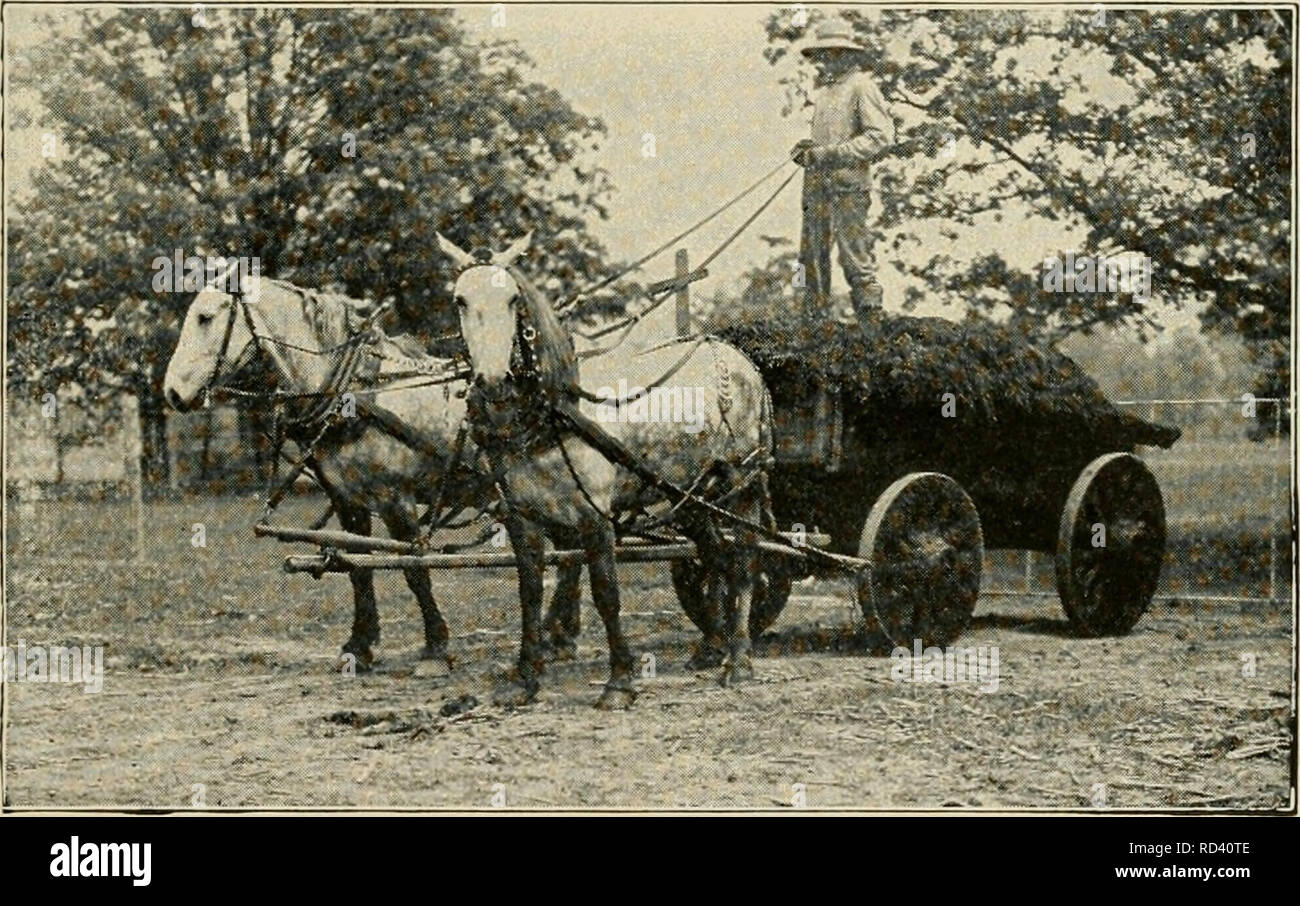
790;19;893;324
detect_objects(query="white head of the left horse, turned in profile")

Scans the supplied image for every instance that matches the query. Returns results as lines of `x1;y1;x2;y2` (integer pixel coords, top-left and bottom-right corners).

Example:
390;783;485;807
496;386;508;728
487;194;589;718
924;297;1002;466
163;285;257;412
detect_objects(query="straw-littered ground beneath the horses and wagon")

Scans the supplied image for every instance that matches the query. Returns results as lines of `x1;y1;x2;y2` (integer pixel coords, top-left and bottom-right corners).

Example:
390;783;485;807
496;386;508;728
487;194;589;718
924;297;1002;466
5;499;1295;810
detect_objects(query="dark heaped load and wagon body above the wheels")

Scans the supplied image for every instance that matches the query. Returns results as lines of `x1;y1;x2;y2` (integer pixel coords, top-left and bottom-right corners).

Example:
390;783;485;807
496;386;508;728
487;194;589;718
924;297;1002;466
722;316;1179;550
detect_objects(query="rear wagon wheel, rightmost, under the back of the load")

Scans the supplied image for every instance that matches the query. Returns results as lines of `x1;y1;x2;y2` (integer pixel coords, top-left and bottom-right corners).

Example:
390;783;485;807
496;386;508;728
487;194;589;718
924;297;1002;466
1056;452;1165;636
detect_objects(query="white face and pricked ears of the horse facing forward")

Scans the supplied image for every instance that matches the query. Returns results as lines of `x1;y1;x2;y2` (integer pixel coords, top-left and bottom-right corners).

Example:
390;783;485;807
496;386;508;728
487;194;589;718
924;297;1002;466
438;233;532;385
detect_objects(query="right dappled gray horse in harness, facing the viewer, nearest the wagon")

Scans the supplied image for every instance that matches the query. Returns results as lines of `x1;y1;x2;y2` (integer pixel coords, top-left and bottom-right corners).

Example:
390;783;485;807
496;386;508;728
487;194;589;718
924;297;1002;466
438;235;772;707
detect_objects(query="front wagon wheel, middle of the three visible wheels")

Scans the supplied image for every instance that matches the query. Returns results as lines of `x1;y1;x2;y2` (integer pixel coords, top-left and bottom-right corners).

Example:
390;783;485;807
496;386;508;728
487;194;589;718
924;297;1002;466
858;472;984;649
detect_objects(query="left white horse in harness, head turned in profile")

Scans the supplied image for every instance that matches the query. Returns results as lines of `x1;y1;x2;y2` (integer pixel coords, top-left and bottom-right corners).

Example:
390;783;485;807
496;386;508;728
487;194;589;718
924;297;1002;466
164;279;581;676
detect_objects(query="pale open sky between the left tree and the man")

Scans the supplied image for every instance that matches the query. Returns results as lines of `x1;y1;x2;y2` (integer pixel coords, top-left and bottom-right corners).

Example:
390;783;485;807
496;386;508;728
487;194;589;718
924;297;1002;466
460;4;807;291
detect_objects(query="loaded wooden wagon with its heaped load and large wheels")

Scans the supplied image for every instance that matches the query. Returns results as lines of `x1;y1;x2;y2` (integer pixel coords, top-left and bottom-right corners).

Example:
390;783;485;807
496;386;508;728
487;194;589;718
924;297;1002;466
673;310;1179;645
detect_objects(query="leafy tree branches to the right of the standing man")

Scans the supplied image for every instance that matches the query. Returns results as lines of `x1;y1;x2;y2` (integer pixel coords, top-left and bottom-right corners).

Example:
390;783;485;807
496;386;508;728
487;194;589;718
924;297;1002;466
766;8;1292;431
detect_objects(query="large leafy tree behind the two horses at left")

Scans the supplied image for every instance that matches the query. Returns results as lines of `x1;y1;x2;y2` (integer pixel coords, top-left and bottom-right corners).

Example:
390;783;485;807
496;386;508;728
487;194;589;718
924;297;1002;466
8;9;610;481
